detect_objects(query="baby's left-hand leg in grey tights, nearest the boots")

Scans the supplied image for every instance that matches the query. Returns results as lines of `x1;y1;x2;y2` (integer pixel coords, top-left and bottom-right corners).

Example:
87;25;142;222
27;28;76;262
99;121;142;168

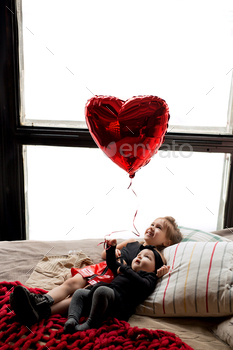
64;289;90;333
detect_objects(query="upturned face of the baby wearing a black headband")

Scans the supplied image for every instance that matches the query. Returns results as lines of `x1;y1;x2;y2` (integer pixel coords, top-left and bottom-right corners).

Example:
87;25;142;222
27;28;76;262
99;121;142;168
131;249;155;272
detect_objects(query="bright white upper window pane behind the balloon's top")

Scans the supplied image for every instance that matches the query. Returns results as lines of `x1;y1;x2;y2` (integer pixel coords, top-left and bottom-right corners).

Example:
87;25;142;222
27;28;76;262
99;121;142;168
19;0;233;128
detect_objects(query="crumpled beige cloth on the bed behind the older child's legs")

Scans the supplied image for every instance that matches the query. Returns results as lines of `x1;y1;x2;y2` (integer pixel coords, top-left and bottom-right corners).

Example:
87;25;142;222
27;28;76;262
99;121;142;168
25;250;93;291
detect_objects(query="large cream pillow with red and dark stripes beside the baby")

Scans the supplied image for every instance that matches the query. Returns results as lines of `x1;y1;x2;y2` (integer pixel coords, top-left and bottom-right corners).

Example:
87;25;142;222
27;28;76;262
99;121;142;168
136;241;233;317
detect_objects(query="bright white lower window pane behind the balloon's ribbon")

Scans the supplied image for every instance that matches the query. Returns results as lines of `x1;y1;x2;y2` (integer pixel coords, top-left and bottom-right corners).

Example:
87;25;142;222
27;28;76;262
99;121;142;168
25;146;228;240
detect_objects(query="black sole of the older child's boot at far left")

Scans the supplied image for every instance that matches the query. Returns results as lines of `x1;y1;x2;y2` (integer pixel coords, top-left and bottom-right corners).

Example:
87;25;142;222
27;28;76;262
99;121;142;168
11;286;39;326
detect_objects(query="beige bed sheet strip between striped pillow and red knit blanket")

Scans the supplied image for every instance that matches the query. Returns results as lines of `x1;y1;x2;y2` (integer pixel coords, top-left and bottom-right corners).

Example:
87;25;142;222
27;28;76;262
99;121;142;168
129;315;229;350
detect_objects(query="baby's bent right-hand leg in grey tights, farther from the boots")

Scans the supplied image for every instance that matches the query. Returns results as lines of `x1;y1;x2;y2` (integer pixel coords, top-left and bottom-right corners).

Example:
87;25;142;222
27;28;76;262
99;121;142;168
74;286;115;331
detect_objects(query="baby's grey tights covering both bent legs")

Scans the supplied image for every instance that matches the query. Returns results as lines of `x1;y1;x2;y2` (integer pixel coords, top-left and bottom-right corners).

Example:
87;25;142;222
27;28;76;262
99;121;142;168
65;286;115;333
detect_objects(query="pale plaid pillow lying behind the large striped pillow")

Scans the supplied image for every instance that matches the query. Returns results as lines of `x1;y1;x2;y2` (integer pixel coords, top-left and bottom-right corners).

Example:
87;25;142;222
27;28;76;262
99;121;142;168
179;226;231;242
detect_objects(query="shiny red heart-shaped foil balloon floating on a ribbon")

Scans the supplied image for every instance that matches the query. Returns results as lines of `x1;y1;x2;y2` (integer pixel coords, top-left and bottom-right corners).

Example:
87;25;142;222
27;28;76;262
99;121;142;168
85;96;170;178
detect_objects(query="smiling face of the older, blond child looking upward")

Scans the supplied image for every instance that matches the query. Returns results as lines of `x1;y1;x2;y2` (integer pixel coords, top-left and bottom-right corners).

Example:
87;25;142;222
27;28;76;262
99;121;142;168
144;218;171;247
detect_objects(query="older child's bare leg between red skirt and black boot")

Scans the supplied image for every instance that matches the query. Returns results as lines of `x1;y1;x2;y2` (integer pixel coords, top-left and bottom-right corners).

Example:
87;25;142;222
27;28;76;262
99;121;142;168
47;273;87;304
